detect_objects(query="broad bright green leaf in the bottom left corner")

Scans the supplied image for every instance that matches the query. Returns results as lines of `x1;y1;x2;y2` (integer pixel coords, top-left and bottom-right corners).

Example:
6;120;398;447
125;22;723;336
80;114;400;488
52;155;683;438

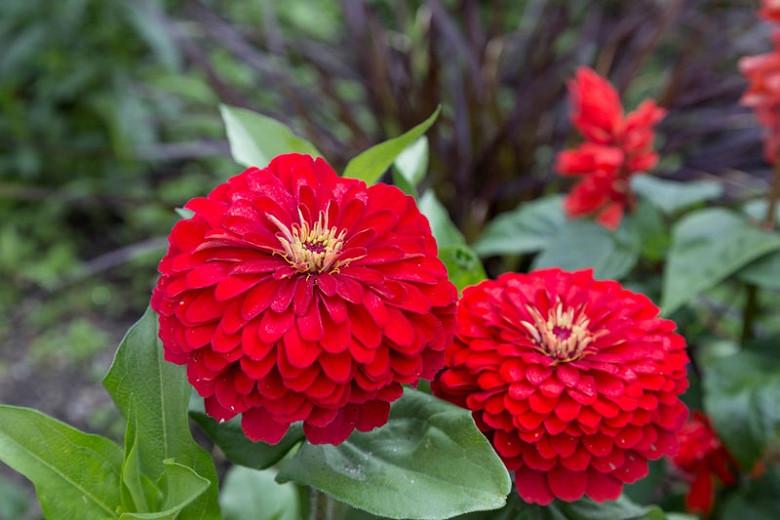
0;405;122;520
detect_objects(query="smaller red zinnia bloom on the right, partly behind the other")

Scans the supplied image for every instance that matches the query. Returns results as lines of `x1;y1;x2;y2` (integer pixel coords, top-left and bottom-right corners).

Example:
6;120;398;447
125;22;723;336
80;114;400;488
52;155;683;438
434;269;688;505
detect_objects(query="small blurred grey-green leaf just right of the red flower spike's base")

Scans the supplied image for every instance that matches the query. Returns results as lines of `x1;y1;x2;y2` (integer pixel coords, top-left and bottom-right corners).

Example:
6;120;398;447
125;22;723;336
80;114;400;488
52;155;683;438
631;175;723;215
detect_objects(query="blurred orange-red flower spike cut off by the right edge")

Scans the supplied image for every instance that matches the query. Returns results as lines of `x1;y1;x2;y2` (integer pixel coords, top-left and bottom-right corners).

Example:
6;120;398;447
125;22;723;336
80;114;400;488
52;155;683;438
739;31;780;163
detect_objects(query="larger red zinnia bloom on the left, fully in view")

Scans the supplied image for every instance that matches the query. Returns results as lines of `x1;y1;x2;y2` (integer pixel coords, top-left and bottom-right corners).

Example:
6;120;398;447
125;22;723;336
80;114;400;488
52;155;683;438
152;154;457;443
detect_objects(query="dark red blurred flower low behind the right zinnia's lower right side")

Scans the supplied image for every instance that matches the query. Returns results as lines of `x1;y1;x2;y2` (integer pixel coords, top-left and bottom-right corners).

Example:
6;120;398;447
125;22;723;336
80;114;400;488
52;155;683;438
672;412;736;514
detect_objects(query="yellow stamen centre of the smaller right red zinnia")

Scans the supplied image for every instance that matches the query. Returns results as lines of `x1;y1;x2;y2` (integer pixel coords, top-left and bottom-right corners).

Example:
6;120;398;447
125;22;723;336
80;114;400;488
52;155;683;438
520;301;606;364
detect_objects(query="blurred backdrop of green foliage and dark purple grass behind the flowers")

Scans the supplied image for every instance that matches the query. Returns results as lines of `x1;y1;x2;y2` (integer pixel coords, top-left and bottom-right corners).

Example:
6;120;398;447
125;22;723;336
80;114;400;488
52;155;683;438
0;0;770;519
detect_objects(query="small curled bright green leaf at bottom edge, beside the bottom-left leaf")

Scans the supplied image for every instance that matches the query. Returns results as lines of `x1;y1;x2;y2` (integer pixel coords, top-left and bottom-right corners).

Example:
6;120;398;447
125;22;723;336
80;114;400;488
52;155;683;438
119;459;210;520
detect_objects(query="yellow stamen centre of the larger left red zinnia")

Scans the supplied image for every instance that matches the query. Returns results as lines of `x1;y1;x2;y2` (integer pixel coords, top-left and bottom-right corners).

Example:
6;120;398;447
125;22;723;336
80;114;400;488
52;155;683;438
267;208;347;274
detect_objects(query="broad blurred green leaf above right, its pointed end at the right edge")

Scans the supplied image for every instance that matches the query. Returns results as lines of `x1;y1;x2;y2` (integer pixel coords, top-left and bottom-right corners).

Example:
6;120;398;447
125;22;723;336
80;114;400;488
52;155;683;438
661;209;780;314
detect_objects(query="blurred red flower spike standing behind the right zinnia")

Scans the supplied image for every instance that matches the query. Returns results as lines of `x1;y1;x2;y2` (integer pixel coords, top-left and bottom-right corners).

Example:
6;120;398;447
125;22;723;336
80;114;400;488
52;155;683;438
556;67;665;229
